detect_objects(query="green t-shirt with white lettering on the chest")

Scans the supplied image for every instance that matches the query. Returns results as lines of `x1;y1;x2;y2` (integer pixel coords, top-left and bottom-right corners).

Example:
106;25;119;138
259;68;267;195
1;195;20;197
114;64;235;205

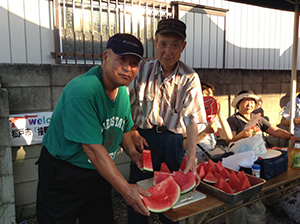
43;66;133;169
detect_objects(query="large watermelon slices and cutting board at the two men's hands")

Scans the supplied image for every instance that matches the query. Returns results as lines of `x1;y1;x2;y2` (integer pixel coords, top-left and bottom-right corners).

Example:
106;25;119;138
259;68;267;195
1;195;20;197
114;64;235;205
137;153;206;213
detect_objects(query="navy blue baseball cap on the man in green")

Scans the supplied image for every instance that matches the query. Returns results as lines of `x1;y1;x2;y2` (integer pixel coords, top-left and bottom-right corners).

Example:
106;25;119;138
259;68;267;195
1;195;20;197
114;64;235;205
106;33;144;60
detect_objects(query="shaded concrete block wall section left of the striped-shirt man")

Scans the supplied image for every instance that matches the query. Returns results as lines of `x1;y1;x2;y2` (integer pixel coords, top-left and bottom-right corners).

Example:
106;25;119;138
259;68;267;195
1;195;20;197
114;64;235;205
0;64;130;224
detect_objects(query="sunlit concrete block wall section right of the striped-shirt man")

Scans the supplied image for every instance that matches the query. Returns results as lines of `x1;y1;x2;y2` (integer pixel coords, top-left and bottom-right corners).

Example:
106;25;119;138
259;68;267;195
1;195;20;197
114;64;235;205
195;69;300;147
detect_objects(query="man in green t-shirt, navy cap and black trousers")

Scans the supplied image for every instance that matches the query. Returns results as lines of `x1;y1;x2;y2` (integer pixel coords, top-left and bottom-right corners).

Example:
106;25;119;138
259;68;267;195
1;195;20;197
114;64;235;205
37;34;150;224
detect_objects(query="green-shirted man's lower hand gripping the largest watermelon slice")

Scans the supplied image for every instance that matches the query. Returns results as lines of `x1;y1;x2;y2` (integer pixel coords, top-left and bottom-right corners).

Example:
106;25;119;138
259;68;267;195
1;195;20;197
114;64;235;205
121;184;151;216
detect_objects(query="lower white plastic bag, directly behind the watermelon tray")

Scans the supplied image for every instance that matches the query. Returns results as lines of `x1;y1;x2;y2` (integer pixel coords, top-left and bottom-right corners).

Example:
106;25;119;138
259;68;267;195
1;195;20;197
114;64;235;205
222;151;258;171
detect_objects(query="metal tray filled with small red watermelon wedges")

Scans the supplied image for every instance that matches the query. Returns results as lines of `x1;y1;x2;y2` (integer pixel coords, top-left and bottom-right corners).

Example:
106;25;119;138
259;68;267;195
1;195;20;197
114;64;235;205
197;160;266;204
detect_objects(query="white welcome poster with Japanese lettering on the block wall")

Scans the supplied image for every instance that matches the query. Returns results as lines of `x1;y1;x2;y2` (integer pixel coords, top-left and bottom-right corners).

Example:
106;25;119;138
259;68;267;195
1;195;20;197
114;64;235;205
9;112;52;146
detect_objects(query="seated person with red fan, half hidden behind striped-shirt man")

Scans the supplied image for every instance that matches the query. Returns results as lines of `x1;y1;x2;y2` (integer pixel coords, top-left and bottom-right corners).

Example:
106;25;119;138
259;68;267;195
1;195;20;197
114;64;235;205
184;82;232;163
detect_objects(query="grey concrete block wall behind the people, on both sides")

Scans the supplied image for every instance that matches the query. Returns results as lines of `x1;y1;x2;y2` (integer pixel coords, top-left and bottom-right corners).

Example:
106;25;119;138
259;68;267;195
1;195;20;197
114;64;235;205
0;64;298;223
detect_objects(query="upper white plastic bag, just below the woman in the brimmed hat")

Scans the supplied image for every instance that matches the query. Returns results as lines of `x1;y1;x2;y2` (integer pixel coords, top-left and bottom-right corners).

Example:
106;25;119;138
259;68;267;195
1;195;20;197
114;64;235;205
229;133;267;156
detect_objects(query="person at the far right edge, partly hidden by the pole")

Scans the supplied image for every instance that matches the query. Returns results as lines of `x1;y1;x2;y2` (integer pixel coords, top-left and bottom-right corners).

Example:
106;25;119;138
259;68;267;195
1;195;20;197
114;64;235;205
279;93;300;137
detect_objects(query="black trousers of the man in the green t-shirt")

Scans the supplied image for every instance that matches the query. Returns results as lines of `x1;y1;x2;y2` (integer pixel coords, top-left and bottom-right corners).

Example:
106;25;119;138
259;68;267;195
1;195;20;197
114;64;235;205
36;147;114;224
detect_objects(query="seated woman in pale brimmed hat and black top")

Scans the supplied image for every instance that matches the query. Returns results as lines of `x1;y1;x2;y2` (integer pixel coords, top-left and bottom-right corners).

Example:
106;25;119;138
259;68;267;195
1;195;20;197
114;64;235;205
227;90;300;143
